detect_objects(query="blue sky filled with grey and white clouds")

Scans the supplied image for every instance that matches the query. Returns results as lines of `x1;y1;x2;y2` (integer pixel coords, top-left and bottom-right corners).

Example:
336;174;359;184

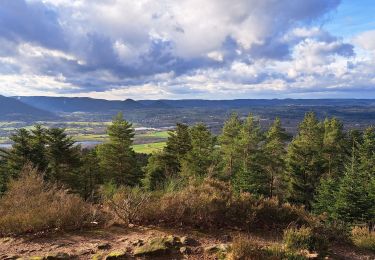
0;0;375;100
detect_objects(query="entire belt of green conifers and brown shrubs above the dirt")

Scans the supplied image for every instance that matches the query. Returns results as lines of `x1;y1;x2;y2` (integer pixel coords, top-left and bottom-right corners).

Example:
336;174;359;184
0;113;375;259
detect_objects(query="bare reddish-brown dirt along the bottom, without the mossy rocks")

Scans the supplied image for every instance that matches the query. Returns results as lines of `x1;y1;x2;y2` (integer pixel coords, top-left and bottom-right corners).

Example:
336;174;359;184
0;224;375;260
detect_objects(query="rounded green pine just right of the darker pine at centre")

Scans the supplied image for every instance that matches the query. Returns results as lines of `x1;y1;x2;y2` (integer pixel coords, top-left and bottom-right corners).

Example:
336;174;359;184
181;124;215;177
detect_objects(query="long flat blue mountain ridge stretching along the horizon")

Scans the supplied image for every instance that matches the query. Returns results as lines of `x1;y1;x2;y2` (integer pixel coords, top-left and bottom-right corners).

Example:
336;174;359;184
8;96;375;113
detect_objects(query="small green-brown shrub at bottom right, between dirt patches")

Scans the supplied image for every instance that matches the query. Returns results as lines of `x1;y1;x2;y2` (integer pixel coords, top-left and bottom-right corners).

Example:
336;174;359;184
283;226;328;256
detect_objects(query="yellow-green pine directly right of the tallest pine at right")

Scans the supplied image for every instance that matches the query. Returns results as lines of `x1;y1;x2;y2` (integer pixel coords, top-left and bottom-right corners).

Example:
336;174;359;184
323;118;349;177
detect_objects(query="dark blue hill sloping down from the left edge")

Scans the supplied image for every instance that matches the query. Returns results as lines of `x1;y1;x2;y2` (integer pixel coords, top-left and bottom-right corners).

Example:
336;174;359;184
0;95;57;121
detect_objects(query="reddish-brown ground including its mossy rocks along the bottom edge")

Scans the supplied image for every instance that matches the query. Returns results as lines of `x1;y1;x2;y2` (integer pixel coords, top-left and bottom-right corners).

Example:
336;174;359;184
0;227;375;260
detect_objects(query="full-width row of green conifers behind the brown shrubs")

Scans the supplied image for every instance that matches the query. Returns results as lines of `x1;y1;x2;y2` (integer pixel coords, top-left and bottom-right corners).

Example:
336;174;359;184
0;113;375;224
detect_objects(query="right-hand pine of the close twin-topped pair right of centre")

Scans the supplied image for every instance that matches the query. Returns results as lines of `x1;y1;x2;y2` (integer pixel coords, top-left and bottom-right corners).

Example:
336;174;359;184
235;114;269;195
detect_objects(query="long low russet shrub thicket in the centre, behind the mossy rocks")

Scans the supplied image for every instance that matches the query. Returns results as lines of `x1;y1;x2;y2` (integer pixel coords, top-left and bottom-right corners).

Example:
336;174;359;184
114;178;311;230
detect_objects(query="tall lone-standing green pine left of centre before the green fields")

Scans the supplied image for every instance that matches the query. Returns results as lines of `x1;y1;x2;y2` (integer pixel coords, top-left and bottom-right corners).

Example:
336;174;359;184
98;113;142;186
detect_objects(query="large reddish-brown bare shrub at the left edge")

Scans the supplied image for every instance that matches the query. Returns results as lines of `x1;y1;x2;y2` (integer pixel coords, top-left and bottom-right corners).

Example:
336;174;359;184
0;166;96;235
